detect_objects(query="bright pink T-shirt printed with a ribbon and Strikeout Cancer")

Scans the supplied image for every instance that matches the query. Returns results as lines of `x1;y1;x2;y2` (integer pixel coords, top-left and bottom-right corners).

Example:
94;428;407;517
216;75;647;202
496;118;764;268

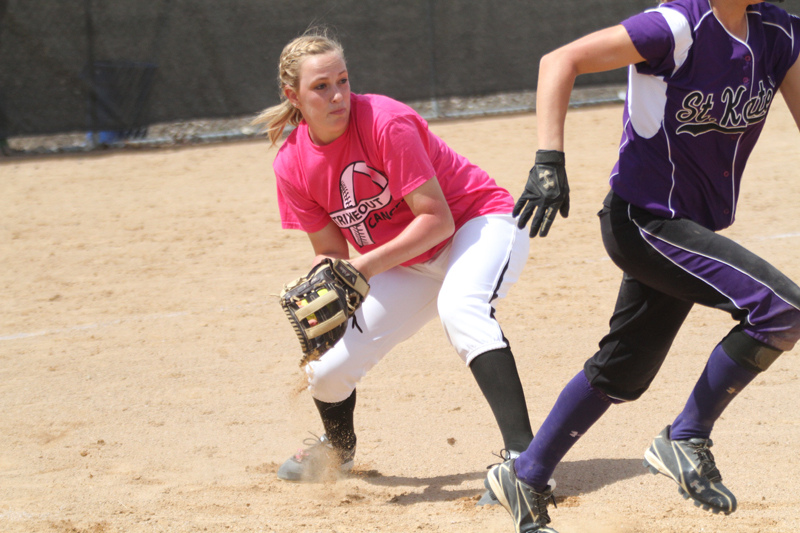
273;93;514;265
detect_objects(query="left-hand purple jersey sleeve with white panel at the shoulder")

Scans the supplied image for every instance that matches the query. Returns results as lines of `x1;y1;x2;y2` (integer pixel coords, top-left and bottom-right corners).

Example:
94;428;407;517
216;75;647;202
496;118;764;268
622;6;692;76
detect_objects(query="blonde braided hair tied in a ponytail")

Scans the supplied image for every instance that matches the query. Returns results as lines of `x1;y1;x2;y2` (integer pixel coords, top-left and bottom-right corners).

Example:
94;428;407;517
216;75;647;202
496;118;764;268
251;28;344;145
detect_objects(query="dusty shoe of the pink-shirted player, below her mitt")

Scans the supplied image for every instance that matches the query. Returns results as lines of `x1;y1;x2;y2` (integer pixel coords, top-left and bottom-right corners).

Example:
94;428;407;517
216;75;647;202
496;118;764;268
278;435;356;482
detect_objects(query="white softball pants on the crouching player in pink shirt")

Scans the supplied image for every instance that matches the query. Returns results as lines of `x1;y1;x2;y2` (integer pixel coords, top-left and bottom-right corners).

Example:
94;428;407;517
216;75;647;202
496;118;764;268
305;214;530;403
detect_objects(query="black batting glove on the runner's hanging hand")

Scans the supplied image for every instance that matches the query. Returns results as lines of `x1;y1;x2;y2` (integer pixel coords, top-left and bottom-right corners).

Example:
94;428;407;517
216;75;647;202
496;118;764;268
512;150;569;238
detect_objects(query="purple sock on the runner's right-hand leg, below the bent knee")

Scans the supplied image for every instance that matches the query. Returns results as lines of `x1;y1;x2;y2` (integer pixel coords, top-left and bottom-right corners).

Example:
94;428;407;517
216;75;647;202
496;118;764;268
670;344;758;440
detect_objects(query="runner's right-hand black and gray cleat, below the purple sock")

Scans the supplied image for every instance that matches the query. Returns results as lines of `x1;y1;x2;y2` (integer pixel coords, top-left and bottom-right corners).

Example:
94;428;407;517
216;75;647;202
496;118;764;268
644;426;736;514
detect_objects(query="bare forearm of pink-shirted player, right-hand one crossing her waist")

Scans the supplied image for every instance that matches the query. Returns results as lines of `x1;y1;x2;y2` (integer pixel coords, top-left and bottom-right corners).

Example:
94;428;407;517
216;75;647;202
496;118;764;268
351;211;455;279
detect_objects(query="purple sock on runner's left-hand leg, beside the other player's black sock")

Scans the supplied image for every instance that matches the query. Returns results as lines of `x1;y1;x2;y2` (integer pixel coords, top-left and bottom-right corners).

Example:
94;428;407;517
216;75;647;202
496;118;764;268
514;370;611;492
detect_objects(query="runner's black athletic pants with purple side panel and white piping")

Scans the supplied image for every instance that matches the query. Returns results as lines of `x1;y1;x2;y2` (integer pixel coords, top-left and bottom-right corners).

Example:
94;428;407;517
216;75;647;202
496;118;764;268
584;192;800;400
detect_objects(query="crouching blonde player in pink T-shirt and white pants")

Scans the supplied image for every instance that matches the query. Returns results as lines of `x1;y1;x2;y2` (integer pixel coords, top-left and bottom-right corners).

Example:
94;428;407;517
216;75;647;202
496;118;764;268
254;32;533;490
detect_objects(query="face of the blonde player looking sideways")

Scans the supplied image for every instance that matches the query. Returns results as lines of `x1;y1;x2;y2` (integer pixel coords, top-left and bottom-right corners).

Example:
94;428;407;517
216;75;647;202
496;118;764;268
286;52;350;144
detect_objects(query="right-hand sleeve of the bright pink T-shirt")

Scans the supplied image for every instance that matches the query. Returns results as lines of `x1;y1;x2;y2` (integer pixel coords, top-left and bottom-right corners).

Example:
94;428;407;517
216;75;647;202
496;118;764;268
379;115;436;198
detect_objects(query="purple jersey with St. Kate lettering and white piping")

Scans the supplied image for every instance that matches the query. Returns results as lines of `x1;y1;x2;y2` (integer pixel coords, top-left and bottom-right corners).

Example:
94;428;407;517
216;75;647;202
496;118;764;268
610;0;800;231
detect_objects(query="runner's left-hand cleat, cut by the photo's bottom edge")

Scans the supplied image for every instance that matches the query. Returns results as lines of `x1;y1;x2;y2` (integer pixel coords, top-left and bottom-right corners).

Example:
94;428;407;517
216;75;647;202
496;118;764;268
483;459;558;533
